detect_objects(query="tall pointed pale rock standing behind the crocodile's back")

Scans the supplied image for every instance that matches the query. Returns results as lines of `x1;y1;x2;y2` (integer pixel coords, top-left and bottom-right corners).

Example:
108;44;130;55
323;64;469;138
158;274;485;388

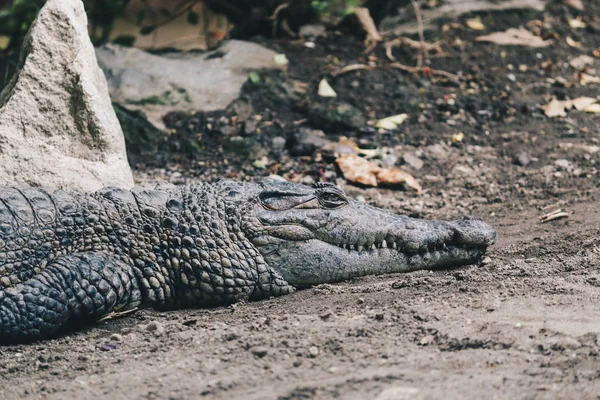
0;0;133;191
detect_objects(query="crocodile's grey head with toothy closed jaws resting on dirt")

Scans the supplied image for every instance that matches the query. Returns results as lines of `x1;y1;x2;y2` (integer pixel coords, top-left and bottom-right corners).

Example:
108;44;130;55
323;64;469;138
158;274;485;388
225;180;496;287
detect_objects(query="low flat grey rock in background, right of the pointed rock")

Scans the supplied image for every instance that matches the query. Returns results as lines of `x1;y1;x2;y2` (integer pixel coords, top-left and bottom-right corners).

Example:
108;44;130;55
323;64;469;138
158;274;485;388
96;40;284;129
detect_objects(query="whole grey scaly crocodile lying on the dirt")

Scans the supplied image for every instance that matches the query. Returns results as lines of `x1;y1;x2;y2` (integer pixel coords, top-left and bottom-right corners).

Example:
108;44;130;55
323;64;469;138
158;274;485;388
0;179;496;344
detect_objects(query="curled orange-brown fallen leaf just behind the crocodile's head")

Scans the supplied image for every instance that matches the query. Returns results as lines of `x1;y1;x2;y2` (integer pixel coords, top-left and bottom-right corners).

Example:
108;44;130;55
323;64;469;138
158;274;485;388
336;154;422;194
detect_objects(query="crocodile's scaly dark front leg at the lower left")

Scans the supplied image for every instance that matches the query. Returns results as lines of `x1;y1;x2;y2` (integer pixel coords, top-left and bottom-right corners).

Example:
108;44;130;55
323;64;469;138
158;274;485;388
0;252;142;343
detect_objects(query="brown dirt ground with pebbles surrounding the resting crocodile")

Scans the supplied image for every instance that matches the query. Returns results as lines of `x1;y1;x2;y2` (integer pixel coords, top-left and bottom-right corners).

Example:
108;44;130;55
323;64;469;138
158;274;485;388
0;2;600;400
